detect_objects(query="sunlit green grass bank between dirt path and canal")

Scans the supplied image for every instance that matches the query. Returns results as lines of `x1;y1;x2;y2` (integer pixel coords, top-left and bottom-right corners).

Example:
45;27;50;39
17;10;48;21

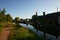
8;25;46;40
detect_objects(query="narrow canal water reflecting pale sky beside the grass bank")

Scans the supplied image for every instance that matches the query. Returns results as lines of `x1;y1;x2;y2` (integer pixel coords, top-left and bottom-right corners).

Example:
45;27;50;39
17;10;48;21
20;23;60;40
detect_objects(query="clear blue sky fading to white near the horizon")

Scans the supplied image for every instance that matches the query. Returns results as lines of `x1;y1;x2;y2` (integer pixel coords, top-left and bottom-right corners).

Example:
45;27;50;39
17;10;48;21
0;0;60;18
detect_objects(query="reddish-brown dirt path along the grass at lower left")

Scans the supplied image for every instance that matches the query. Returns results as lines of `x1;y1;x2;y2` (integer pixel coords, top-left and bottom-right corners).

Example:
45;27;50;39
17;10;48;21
0;27;12;40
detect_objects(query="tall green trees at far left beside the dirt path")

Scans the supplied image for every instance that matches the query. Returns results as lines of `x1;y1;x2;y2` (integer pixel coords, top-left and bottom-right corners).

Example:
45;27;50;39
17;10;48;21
0;8;12;22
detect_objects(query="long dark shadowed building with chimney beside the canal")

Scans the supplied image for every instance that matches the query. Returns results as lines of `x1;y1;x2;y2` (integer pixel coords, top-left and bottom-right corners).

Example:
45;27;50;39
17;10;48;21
31;12;60;26
